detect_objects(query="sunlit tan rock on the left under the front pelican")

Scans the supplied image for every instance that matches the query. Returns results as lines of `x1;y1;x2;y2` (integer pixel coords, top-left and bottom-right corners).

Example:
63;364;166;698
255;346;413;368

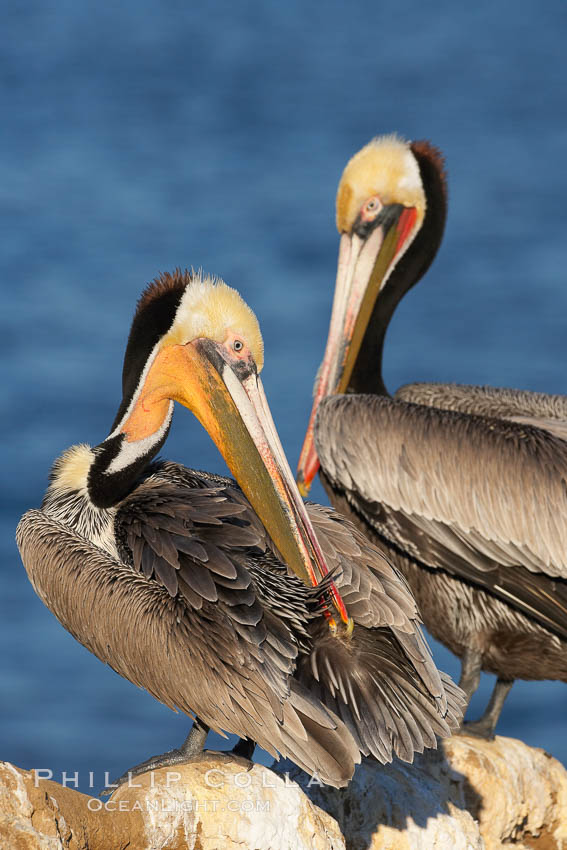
0;754;345;850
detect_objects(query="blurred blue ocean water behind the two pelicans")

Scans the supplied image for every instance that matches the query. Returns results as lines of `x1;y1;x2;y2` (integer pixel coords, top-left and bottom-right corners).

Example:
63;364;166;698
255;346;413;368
0;0;567;790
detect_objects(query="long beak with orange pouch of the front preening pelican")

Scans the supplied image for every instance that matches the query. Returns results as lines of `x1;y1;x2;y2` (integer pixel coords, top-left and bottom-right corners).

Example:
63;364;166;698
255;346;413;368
159;338;349;625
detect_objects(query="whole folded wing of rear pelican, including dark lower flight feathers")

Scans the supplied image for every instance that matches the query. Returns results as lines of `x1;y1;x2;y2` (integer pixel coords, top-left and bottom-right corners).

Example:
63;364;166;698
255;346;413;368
316;385;567;637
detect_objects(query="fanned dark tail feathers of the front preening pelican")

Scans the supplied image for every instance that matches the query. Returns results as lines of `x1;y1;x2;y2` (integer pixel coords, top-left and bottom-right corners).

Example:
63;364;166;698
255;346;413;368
299;624;464;763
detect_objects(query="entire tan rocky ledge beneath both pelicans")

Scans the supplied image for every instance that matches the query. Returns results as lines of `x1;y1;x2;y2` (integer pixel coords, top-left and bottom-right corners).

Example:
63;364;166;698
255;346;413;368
0;736;567;850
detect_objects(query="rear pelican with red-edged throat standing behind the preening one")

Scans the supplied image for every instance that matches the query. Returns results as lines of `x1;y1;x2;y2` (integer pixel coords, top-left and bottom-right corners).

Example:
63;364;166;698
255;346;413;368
298;136;567;736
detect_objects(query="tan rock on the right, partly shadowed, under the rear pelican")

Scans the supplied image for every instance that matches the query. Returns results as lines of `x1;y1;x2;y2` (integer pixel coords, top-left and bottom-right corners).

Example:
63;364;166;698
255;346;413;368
282;735;567;850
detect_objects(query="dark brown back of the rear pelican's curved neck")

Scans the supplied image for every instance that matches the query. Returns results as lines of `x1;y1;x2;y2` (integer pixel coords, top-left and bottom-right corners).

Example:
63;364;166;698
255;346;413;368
348;142;447;395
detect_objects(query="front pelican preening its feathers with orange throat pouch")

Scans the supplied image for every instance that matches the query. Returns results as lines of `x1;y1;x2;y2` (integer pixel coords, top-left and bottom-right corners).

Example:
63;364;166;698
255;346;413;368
17;272;462;786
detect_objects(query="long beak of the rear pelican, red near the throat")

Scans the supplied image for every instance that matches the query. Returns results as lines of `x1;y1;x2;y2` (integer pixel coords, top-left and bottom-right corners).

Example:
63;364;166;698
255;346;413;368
297;204;417;496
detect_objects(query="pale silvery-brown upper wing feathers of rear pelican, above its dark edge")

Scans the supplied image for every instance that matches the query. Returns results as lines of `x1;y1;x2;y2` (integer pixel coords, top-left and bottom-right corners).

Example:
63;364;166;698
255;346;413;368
316;395;567;579
